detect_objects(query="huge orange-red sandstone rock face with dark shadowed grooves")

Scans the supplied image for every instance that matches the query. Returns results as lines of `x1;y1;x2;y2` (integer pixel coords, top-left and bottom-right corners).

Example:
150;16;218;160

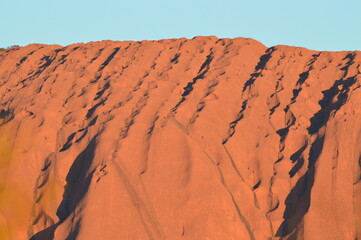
0;37;361;240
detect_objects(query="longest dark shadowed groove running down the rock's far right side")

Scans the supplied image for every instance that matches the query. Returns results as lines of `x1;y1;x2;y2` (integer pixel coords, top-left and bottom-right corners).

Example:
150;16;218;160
276;53;355;237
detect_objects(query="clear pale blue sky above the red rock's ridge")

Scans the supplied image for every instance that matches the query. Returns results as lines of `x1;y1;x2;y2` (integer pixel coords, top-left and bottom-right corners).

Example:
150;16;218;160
0;0;361;51
